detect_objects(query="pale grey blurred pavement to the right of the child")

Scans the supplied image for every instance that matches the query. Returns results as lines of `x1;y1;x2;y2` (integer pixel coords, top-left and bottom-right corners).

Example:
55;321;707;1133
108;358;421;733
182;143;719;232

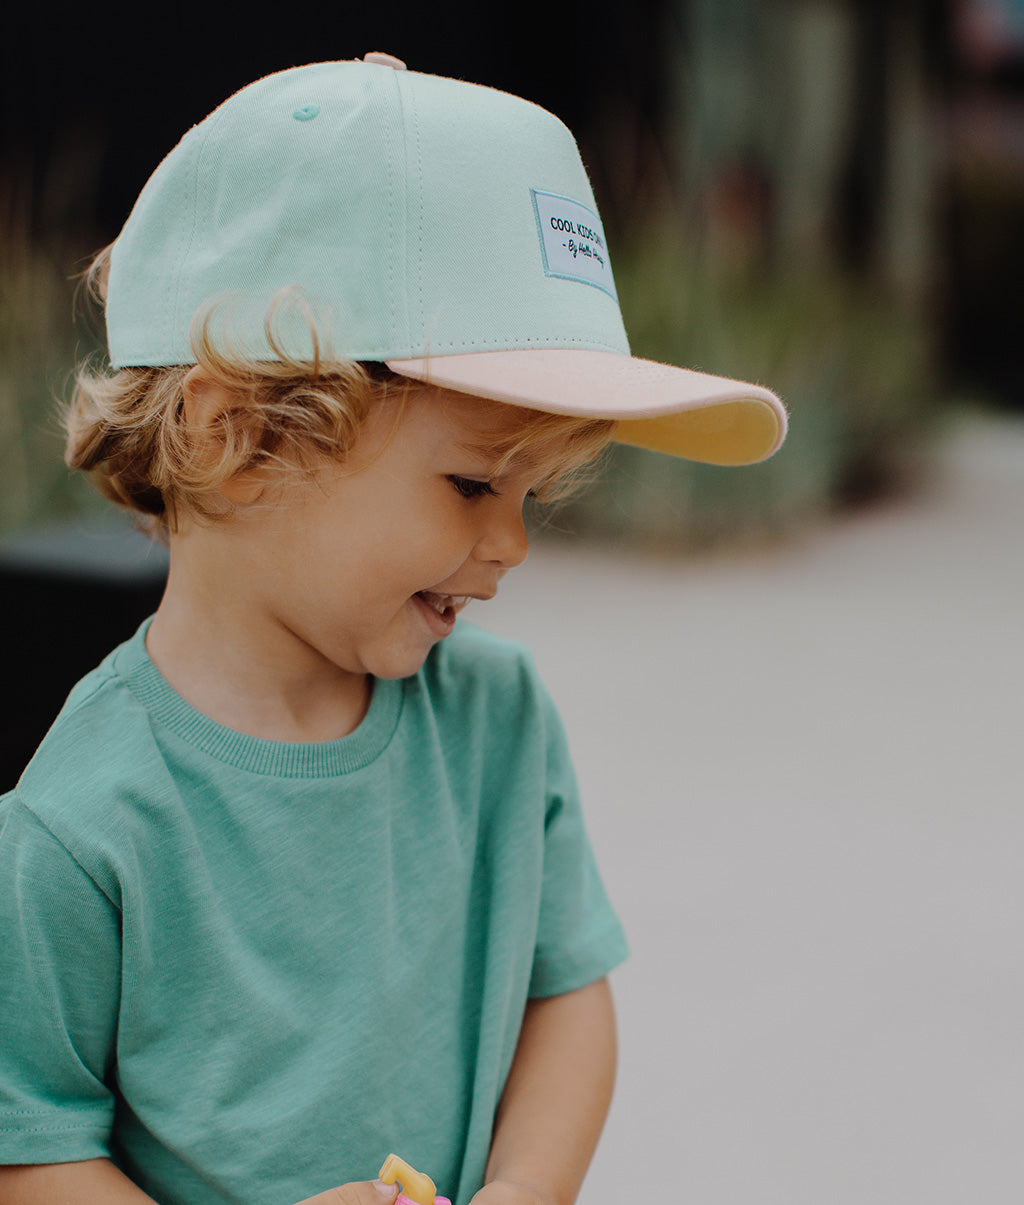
467;418;1024;1205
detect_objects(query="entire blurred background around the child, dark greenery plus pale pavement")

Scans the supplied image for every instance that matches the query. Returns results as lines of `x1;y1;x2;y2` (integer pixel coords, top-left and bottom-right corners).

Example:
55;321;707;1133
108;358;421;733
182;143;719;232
0;0;1024;1205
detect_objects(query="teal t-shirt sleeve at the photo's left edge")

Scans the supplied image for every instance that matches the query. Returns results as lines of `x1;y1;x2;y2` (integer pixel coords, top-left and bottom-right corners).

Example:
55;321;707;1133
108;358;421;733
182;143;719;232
0;797;120;1163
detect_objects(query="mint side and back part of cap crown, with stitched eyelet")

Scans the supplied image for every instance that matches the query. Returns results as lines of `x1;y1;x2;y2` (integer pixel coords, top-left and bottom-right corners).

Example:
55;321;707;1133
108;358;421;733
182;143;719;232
108;63;408;364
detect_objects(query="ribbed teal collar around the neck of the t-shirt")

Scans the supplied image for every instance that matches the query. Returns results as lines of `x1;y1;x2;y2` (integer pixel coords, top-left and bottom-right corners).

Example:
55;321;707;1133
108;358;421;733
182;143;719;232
114;619;405;778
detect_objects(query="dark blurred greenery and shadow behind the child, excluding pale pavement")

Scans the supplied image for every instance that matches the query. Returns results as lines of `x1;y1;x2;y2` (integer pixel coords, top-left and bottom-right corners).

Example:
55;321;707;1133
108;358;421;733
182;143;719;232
0;0;1024;788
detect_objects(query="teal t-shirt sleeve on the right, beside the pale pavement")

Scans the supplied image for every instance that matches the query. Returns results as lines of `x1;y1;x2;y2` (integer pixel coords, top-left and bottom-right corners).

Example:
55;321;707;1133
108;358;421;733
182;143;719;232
529;692;629;998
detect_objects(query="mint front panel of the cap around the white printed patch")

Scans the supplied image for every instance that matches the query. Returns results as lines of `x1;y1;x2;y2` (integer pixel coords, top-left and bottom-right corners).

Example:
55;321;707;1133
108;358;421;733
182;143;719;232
389;72;629;359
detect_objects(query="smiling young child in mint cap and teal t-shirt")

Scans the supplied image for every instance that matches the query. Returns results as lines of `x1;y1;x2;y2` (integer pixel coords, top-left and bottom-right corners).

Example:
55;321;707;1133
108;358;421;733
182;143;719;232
0;54;785;1205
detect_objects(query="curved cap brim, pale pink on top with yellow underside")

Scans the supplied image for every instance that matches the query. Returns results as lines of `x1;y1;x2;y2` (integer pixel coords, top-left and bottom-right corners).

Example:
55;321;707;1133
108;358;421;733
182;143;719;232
387;348;787;465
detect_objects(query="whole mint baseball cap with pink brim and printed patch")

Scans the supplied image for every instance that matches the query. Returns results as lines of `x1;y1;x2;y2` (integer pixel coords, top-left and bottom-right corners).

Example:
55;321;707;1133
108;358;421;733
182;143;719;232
106;52;787;464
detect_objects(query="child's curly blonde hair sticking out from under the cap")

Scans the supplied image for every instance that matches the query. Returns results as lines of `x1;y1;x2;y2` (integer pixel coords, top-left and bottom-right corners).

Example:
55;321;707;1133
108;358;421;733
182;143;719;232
65;247;613;539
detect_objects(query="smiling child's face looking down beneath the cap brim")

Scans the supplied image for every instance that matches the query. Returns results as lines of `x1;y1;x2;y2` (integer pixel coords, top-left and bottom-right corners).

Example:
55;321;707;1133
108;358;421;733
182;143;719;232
218;388;559;678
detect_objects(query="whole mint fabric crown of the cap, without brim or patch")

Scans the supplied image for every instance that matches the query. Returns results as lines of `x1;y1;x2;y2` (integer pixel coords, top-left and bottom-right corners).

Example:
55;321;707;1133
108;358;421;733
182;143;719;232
108;63;629;364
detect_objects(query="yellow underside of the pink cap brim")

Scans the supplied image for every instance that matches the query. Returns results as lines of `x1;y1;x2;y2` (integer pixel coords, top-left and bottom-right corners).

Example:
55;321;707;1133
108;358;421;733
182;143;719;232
612;398;782;465
